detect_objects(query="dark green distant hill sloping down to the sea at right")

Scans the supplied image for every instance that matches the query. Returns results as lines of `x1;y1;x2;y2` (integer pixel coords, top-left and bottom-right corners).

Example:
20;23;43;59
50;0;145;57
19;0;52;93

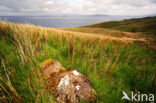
84;16;156;35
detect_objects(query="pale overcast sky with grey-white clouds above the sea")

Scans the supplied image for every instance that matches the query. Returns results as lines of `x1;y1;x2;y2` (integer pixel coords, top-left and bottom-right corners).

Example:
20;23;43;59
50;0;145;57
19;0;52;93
0;0;156;15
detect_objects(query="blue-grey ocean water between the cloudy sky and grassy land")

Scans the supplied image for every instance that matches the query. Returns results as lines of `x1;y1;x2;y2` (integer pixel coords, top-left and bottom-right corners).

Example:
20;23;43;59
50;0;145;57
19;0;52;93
0;15;139;27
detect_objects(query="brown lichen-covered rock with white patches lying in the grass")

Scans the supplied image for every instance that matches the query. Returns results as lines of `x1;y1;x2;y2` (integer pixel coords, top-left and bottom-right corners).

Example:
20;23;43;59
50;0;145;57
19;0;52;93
40;59;96;103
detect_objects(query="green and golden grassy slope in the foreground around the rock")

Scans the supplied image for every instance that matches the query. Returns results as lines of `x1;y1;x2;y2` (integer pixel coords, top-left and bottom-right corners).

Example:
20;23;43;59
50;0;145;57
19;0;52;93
0;21;156;103
